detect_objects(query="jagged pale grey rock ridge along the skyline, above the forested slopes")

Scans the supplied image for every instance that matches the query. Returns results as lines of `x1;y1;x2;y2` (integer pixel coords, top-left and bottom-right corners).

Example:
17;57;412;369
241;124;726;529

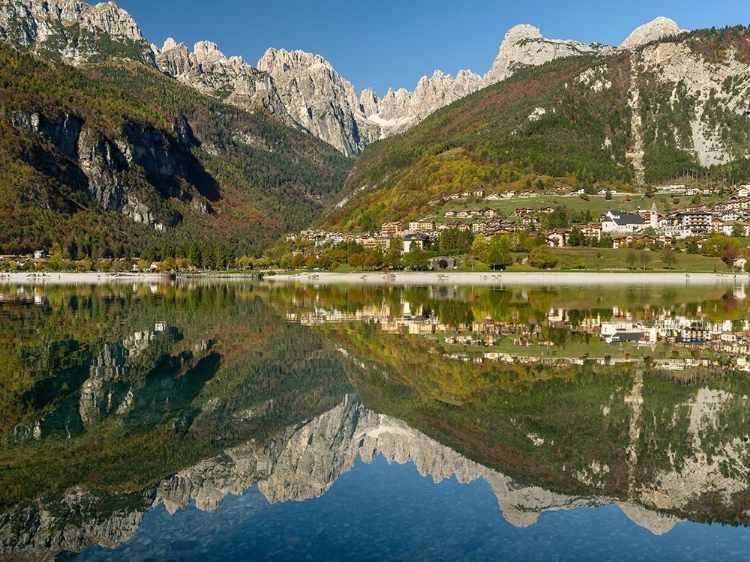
0;0;692;156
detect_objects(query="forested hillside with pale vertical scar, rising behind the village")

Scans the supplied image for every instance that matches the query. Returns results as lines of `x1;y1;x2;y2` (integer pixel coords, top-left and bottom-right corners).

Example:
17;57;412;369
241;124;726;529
323;27;750;231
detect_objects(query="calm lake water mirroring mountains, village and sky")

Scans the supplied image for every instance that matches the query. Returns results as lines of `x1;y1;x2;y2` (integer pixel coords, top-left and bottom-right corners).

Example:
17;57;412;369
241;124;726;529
0;283;750;561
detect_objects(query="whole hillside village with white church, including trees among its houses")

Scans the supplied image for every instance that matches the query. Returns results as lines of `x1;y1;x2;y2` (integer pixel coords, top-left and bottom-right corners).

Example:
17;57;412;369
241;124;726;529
287;185;750;269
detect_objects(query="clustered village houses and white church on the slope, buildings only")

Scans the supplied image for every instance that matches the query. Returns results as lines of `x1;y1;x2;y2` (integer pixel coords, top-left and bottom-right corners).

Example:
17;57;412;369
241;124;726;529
296;185;750;252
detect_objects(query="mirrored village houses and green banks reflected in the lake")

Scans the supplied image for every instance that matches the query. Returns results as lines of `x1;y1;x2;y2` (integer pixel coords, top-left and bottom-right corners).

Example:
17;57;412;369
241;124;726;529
287;280;750;372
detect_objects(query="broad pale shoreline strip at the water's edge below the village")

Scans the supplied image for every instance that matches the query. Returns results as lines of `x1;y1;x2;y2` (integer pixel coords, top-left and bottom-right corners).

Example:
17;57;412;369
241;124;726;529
264;271;750;286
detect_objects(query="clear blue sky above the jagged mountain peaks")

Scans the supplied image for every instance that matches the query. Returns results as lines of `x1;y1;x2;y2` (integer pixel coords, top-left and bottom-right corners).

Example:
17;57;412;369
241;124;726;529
114;0;750;96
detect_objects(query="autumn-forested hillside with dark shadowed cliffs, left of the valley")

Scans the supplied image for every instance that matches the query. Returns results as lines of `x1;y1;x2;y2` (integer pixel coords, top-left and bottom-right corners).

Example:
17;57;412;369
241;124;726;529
0;45;351;258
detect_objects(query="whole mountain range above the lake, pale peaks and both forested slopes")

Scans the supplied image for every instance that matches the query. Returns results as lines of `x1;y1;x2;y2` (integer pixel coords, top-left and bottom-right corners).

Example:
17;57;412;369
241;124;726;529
0;0;750;255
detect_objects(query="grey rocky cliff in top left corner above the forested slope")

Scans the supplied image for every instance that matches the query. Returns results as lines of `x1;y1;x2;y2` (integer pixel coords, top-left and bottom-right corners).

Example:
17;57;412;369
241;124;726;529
0;0;153;65
